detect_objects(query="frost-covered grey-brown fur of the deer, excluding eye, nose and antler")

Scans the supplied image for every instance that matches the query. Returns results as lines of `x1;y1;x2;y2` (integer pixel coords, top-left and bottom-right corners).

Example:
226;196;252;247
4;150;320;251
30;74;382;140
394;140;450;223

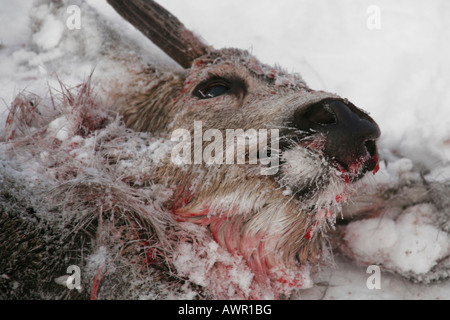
0;1;450;299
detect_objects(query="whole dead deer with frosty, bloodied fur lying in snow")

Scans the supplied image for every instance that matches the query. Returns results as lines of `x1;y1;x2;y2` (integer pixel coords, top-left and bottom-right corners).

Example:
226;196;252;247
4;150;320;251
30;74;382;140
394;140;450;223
0;0;448;298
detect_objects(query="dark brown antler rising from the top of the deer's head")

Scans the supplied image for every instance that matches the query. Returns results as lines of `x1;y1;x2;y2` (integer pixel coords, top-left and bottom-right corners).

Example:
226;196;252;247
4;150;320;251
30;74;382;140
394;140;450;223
108;0;212;69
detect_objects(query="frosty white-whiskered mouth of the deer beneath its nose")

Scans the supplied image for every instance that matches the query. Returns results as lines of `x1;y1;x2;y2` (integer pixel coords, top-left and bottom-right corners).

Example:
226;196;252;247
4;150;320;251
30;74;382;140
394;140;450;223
276;134;379;205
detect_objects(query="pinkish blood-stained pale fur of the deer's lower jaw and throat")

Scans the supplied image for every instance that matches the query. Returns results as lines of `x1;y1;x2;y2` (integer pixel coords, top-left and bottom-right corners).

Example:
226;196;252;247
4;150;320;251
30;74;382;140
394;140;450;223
173;175;342;297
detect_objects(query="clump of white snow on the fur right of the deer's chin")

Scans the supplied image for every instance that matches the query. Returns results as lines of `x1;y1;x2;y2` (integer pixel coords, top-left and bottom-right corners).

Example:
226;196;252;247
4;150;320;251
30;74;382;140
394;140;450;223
344;204;450;274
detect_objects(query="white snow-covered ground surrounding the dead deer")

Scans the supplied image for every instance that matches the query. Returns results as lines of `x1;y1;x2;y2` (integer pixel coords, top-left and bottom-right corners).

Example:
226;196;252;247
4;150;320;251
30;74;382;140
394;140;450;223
0;0;450;299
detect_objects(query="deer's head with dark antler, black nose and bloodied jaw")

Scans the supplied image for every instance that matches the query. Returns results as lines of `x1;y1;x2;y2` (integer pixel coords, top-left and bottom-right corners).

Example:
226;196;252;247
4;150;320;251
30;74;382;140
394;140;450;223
108;0;380;296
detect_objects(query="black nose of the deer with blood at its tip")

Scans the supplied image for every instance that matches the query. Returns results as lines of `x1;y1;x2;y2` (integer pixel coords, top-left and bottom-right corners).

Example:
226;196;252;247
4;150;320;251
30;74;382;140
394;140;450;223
293;99;380;172
